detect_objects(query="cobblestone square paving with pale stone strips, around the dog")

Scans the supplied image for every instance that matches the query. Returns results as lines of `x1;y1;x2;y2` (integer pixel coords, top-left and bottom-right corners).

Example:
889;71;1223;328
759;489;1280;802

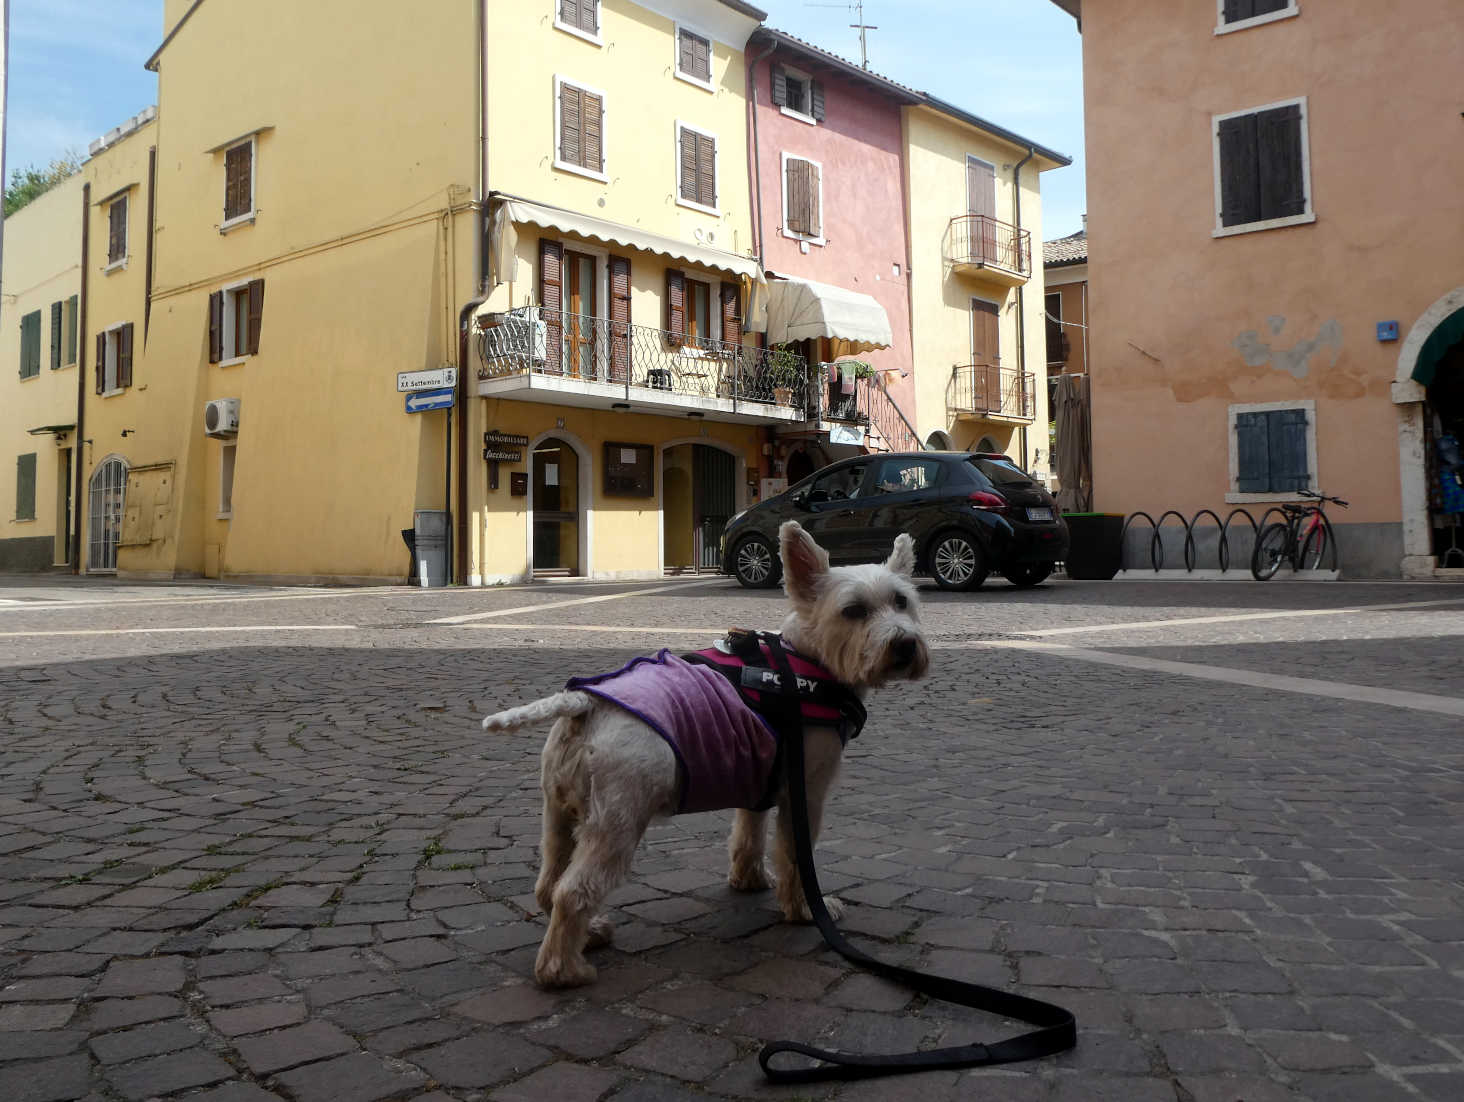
0;578;1464;1102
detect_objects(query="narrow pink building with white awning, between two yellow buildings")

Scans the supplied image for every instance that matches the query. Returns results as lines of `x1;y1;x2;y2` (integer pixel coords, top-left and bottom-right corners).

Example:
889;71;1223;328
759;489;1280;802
747;28;922;481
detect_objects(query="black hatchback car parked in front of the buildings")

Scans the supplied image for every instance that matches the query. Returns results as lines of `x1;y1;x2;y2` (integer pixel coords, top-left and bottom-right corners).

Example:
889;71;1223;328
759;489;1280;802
722;452;1067;590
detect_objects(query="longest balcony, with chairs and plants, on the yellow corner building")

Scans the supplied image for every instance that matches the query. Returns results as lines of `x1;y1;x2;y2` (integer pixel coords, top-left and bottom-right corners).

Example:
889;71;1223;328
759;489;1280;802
477;307;808;424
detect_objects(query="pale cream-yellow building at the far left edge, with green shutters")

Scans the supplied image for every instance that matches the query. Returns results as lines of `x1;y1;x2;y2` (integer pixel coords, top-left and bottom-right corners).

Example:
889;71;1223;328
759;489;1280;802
0;174;82;572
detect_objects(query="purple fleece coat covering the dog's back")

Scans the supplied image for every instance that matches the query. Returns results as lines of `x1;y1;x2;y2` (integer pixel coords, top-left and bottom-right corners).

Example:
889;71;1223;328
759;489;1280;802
565;650;777;815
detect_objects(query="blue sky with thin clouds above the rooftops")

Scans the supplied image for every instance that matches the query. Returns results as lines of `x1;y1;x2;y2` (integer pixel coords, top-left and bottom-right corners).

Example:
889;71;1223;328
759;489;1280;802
6;0;1086;240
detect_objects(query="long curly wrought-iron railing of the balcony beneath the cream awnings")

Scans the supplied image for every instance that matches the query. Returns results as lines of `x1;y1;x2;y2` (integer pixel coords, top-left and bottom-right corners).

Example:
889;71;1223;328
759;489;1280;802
477;307;808;410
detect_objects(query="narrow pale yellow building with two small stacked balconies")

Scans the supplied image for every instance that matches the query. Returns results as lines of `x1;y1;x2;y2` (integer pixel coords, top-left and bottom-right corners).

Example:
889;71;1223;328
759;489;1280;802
905;97;1072;479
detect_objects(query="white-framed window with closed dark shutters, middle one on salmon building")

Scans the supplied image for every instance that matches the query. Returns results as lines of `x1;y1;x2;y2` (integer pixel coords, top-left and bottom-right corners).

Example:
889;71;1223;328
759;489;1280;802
1214;100;1316;237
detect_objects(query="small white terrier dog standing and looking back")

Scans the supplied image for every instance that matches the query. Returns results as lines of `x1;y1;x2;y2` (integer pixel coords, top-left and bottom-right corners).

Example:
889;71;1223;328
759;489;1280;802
483;521;930;986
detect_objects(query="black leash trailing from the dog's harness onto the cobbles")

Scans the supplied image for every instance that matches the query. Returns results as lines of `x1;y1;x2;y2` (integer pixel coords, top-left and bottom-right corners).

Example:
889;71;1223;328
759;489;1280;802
758;632;1078;1083
